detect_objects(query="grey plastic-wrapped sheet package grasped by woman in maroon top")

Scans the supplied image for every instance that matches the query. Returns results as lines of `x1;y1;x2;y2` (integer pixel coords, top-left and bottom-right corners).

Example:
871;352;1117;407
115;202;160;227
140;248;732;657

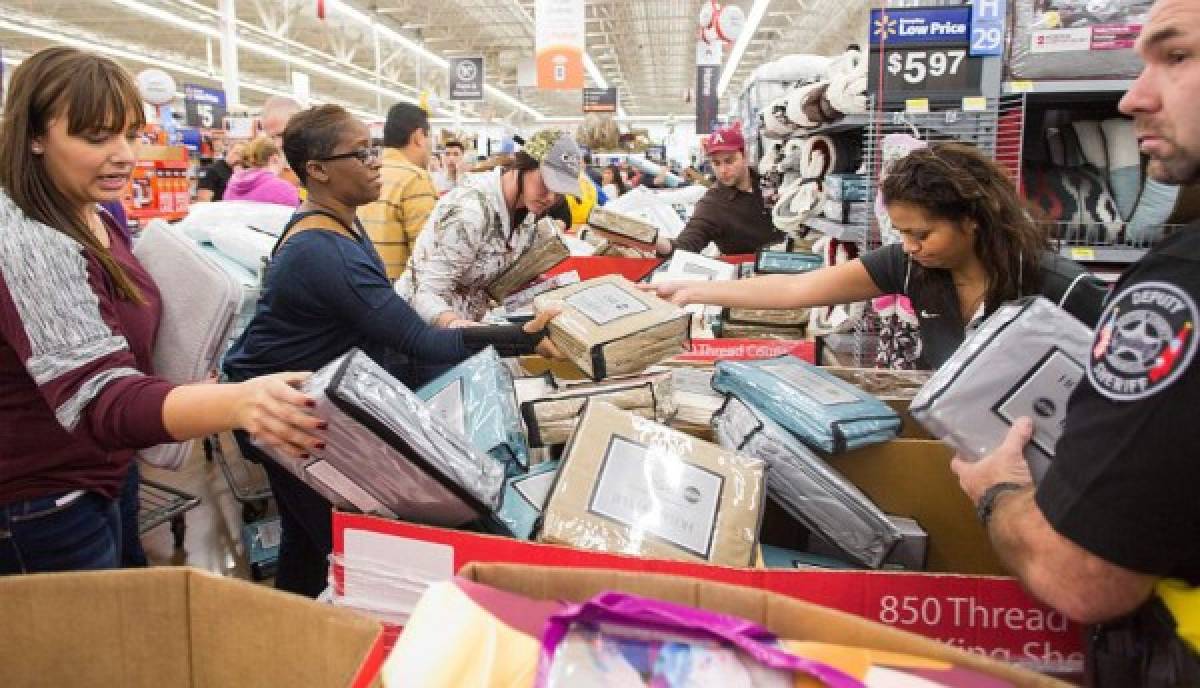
272;349;504;526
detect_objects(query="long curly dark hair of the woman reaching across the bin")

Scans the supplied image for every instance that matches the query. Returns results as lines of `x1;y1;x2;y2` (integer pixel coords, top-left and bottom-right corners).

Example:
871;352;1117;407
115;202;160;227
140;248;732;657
881;143;1049;306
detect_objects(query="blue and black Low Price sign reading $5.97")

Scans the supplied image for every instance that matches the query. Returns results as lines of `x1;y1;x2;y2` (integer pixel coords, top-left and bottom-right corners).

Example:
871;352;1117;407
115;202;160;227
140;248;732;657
866;7;983;102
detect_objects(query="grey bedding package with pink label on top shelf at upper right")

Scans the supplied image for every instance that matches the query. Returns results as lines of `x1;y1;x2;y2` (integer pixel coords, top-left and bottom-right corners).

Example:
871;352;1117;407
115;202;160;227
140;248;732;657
1004;0;1153;79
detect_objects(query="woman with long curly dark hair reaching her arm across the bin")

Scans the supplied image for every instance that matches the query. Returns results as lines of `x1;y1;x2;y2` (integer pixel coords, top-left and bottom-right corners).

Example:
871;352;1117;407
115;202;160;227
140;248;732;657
648;143;1106;369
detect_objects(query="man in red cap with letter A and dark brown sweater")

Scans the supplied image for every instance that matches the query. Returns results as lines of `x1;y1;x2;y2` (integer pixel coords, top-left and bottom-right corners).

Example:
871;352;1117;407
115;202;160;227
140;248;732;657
658;125;784;256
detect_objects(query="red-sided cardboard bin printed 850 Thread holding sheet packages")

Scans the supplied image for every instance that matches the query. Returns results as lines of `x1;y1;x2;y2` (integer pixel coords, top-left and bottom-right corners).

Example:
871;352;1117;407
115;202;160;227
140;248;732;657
334;439;1084;675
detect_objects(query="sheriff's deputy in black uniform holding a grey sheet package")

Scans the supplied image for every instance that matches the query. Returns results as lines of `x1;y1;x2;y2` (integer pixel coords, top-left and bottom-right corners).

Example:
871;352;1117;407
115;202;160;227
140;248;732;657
952;0;1200;687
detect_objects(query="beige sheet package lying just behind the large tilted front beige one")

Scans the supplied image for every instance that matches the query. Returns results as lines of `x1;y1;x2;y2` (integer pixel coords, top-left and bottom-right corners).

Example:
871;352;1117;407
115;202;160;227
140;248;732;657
521;372;676;447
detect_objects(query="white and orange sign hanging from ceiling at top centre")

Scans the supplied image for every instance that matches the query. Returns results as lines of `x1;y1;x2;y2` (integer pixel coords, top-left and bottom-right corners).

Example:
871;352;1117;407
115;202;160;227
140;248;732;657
534;0;586;90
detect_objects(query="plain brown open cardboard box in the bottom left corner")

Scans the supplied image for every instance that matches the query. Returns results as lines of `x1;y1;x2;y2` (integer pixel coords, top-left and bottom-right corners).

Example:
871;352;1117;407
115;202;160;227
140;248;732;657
0;568;384;688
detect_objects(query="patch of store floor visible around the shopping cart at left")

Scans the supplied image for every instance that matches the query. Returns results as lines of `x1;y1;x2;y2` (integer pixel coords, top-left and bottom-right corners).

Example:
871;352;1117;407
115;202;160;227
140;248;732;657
142;436;265;580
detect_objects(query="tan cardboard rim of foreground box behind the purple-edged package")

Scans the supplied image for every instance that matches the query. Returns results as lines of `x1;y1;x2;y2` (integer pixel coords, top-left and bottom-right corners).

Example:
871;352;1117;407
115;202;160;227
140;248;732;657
458;563;1062;686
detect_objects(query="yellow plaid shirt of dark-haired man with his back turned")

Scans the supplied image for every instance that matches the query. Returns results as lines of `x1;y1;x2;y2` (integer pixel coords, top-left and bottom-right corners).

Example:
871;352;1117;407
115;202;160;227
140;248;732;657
359;148;438;280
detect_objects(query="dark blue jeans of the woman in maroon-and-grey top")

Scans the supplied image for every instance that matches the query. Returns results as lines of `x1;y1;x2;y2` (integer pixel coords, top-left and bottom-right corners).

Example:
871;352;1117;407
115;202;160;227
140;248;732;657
0;492;121;575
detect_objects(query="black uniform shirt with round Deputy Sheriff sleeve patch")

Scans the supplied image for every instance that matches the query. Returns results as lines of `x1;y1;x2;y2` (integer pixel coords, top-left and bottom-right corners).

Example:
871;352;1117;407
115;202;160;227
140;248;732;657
1037;228;1200;586
